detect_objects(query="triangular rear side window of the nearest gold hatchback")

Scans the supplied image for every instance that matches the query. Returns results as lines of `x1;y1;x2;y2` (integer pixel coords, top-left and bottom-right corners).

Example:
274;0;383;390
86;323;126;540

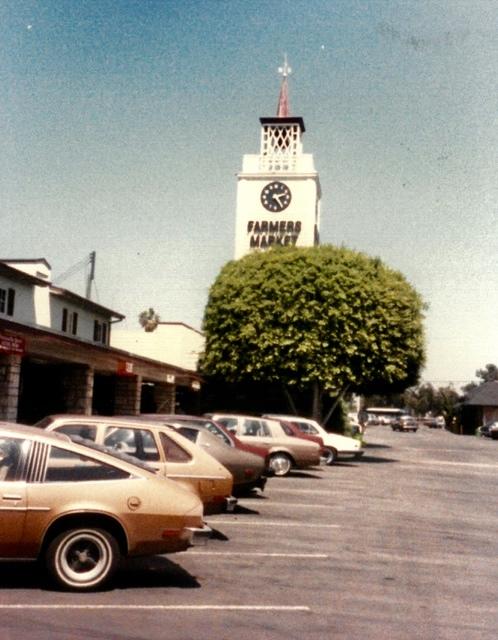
45;446;130;482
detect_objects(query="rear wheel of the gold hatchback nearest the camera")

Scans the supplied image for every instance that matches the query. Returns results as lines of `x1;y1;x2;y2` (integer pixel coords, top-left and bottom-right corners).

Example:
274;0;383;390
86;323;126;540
45;527;120;591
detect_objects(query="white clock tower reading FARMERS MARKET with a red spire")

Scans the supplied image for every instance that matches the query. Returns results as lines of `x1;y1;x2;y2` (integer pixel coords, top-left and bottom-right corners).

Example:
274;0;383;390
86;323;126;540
235;59;321;259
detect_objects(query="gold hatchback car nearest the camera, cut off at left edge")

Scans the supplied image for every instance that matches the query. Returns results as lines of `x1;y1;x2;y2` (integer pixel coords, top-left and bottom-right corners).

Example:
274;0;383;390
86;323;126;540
0;422;210;591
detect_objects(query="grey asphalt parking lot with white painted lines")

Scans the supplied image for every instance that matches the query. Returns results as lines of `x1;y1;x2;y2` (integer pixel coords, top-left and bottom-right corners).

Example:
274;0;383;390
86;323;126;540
0;427;498;640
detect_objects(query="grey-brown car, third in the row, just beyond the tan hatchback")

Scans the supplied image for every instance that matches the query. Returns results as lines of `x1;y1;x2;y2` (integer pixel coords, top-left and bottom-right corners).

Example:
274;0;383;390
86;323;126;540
138;416;268;496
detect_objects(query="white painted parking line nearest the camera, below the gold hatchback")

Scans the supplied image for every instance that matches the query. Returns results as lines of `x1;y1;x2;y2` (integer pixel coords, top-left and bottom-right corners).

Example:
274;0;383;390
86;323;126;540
0;604;311;613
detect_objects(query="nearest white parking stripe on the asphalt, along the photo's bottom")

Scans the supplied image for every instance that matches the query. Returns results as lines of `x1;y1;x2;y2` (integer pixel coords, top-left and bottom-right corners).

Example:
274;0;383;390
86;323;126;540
0;604;311;613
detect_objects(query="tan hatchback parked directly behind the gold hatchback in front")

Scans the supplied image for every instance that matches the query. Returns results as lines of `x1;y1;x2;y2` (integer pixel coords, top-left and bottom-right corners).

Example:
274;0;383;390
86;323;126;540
36;414;237;514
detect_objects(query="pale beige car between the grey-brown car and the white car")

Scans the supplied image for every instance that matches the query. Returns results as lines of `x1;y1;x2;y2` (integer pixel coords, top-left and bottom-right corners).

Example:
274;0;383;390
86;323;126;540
207;413;320;476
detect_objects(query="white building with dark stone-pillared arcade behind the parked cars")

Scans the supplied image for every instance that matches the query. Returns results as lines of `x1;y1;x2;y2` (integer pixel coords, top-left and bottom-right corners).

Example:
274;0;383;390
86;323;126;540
0;258;200;423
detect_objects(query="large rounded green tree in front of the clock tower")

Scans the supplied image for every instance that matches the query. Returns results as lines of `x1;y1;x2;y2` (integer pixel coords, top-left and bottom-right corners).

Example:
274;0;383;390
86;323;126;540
202;245;424;417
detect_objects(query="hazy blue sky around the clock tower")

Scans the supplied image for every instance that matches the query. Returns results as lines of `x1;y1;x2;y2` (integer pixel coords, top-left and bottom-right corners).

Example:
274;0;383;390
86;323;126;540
0;0;498;384
